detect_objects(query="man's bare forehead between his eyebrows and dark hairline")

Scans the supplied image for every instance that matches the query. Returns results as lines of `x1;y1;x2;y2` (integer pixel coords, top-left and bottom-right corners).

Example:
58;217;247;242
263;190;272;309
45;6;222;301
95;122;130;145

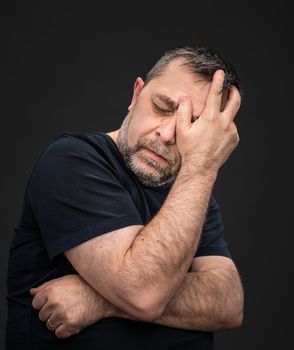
143;61;210;115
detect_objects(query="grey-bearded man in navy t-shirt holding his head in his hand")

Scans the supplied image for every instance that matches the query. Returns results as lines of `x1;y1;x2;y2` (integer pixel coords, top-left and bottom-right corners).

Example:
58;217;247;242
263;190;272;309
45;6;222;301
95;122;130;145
7;46;243;349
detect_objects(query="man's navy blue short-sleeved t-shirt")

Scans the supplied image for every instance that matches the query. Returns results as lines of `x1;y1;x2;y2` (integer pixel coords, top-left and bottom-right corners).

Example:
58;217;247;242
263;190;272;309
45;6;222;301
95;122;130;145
6;132;230;350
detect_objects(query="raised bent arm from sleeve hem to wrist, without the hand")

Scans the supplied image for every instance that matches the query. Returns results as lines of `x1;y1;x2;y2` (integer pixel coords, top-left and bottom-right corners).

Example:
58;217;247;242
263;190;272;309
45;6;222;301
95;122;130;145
65;173;214;321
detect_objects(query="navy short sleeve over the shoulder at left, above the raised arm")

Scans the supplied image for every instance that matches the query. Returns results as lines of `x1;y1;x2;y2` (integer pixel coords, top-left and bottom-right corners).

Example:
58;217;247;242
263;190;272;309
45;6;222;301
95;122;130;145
28;135;142;258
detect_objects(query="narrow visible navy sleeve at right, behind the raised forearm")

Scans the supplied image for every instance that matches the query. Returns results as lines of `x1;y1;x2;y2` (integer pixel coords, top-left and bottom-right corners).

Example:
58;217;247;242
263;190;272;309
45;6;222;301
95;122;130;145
195;196;231;258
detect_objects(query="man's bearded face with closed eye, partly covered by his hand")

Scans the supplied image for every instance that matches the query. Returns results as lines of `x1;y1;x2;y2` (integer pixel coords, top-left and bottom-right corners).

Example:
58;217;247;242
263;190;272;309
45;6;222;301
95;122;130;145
118;60;210;187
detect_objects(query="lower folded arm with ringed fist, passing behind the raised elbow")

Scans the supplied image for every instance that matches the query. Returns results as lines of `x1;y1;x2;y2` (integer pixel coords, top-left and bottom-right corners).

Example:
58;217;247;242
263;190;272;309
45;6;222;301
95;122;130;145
32;256;243;338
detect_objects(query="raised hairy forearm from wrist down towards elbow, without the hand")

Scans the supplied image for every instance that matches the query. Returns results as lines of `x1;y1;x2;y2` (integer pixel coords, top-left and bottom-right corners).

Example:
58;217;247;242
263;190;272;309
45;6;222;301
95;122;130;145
122;171;215;308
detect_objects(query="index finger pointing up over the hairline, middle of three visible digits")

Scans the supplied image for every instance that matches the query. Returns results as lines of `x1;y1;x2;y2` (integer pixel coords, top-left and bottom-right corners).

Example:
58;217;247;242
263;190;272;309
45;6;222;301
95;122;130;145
202;69;225;117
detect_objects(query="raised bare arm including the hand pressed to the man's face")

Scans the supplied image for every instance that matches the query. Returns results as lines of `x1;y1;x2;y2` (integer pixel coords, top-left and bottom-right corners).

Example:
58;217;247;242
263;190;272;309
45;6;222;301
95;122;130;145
65;74;240;321
